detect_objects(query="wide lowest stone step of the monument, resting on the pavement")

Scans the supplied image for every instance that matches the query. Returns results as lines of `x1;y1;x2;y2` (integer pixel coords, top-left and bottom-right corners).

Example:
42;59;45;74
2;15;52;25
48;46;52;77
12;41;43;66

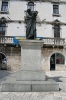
1;79;59;92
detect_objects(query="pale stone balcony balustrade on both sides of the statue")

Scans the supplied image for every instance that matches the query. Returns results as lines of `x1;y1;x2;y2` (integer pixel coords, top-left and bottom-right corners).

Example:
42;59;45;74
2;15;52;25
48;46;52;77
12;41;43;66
0;36;66;46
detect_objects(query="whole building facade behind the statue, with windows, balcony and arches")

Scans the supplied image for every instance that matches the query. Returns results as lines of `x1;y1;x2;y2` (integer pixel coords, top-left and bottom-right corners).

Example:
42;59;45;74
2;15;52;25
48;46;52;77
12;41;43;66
0;0;66;71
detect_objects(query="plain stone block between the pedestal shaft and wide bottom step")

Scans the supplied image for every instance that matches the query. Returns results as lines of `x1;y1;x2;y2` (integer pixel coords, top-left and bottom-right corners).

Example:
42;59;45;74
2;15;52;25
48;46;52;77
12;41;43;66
16;71;45;81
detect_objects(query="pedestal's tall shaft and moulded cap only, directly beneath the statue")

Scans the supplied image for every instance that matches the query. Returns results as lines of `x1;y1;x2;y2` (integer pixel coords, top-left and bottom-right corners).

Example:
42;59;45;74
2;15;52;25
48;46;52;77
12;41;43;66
20;40;43;71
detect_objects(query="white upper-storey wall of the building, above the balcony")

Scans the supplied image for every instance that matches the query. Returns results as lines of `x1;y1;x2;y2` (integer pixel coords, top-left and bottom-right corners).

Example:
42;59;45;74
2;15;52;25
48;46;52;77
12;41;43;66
0;0;66;38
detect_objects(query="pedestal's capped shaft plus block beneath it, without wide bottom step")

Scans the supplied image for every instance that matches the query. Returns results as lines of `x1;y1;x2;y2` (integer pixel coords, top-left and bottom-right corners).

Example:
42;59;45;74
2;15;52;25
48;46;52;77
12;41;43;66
17;40;45;81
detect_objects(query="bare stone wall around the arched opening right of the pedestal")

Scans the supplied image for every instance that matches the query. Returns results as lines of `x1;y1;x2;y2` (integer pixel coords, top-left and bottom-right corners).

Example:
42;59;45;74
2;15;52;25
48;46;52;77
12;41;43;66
41;48;66;71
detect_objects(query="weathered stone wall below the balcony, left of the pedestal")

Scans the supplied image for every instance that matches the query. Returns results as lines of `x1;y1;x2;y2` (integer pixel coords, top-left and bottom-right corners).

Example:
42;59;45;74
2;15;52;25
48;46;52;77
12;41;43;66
6;47;21;71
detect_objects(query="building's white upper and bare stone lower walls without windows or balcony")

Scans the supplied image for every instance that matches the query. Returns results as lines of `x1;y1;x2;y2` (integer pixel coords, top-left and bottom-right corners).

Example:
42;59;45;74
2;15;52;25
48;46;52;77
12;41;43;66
0;0;66;71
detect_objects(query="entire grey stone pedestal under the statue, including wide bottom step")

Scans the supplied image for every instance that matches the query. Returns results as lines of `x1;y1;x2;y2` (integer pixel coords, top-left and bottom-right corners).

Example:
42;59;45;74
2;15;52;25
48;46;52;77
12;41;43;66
2;40;59;92
